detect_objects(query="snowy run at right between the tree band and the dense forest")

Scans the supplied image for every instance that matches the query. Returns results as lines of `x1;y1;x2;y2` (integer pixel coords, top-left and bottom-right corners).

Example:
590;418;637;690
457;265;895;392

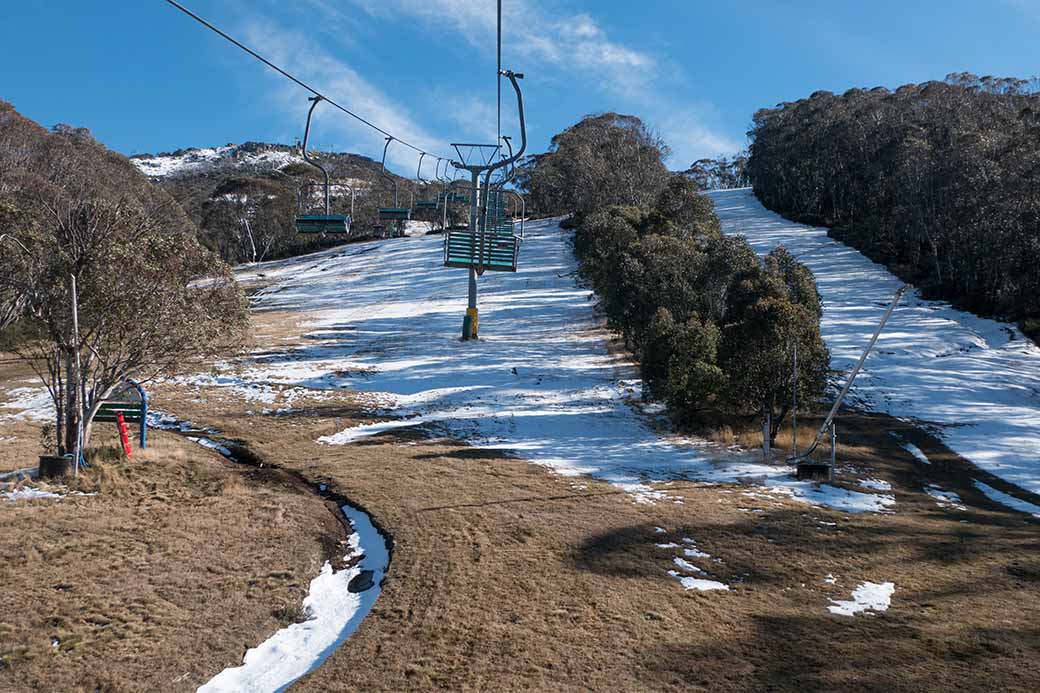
710;189;1040;493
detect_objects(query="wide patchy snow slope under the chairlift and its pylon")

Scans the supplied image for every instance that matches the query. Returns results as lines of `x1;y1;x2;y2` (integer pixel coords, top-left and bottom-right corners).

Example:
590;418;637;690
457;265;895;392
221;222;894;512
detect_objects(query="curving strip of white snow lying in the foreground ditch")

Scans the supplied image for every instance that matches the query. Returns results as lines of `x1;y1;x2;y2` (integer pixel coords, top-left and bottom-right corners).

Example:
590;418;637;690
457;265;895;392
199;506;390;693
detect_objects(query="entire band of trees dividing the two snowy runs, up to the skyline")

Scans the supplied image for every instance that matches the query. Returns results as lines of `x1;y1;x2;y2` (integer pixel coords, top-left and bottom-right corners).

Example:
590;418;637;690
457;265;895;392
526;113;829;437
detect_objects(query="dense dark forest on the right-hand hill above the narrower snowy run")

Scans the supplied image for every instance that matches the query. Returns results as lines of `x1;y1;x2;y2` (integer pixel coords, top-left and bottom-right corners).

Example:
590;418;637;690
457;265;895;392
749;74;1040;338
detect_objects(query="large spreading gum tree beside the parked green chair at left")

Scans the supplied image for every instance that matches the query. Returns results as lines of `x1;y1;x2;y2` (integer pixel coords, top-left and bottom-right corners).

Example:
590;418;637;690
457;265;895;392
0;98;248;454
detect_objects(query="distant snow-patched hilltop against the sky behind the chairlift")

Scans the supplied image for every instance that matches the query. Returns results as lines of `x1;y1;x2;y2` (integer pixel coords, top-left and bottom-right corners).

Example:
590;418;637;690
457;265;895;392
130;142;303;178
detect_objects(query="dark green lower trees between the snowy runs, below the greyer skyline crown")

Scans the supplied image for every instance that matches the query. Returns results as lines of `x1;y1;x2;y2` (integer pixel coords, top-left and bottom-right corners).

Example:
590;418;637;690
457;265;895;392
574;176;830;438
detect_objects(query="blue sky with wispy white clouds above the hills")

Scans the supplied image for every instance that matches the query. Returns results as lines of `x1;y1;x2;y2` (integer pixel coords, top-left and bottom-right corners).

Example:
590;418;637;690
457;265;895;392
0;0;1040;173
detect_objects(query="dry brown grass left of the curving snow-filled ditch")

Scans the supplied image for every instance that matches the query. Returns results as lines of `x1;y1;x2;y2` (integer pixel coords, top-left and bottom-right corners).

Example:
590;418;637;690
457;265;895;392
0;420;344;691
